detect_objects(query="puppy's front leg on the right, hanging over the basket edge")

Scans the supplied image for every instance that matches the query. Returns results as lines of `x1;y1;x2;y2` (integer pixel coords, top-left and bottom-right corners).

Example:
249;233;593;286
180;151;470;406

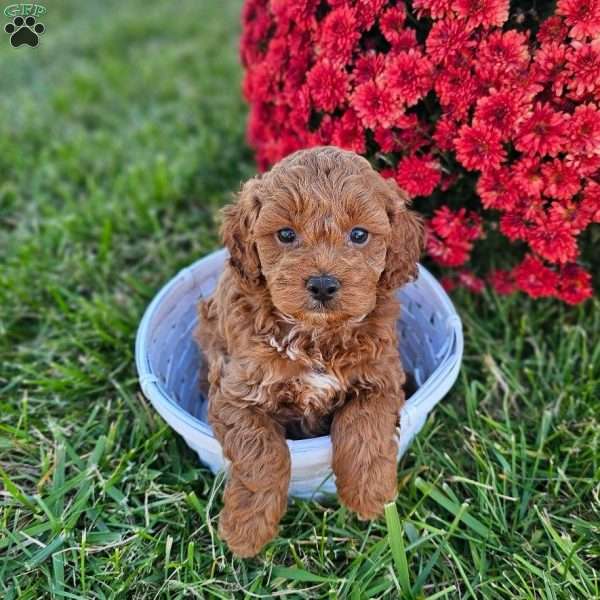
331;387;404;519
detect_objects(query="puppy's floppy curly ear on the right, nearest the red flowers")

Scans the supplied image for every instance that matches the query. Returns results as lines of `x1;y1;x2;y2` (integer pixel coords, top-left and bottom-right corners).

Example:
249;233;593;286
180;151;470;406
379;179;425;290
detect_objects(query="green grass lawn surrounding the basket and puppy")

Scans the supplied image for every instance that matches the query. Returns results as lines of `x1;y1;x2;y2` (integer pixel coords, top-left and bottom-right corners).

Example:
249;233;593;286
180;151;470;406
0;0;600;600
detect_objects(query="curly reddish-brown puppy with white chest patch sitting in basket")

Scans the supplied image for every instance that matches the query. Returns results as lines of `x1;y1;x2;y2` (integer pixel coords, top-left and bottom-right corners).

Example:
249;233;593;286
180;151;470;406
195;146;423;557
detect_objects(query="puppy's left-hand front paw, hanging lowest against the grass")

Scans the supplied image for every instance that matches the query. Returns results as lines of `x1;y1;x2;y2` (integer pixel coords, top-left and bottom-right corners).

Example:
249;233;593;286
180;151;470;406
219;506;278;558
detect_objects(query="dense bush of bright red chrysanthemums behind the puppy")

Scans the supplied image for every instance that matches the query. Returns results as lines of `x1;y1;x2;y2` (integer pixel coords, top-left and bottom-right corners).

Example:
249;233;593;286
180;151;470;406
241;0;600;304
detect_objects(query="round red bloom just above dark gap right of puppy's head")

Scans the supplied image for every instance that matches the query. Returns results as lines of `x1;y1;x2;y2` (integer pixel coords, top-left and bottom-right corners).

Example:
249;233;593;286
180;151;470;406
454;125;506;171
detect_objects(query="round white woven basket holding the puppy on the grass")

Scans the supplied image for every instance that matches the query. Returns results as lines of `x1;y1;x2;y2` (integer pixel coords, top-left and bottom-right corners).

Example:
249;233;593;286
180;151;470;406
135;250;463;498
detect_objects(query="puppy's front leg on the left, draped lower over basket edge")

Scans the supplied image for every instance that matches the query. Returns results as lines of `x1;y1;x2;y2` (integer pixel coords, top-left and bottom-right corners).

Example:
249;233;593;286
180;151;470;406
209;390;290;557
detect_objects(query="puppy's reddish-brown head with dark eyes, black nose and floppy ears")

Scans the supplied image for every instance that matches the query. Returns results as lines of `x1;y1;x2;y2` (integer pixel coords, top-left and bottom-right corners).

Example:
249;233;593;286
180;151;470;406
222;147;423;324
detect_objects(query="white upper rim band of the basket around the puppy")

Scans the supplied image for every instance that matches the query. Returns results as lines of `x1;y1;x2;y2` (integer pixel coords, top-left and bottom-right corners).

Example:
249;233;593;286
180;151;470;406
135;248;464;453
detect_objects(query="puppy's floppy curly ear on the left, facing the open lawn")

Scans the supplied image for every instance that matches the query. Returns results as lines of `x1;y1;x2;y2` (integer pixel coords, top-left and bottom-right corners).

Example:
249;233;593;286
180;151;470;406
221;177;262;285
